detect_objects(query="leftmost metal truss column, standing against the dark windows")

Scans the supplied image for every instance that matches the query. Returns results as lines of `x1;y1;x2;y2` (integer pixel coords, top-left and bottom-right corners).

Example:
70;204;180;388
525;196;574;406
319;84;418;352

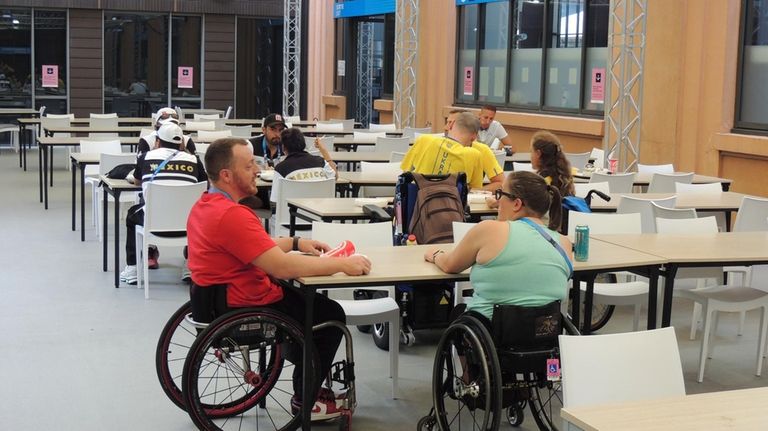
283;0;301;115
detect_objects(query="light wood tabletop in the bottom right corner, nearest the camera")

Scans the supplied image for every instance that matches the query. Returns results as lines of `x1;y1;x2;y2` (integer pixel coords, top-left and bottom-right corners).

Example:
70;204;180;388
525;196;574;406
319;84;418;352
560;387;768;431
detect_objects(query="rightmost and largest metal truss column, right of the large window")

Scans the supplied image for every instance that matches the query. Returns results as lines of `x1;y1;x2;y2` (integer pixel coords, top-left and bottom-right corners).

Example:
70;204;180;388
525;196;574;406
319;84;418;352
603;0;648;172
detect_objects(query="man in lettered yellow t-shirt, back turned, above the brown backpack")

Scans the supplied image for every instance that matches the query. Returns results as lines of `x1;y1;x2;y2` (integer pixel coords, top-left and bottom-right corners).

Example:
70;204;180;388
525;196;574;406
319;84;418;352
400;112;483;189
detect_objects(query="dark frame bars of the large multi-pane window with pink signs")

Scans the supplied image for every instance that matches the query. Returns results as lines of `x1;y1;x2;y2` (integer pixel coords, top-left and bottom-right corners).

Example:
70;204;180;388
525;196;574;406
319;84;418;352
453;0;610;117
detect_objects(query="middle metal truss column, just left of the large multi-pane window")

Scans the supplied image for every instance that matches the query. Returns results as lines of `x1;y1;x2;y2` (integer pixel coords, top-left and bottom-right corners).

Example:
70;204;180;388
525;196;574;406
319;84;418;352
393;0;419;128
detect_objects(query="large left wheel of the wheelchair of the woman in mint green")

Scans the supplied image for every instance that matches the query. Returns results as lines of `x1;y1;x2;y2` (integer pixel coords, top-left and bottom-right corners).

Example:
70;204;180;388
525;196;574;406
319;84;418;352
432;316;501;431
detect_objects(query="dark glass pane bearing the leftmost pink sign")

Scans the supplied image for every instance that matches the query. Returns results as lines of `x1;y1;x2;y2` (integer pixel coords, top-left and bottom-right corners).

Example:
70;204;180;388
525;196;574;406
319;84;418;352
34;10;68;114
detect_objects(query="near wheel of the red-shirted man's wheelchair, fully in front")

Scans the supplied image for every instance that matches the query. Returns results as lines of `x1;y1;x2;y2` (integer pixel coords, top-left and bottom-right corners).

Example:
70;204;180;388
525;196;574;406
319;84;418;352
182;308;318;430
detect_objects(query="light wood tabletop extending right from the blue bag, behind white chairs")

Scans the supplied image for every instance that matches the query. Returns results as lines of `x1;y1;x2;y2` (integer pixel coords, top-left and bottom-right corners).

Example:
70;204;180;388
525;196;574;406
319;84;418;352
591;192;747;211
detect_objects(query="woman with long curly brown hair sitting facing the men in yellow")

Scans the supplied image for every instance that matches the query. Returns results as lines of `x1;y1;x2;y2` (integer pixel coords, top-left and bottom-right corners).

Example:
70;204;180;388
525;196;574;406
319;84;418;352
531;130;574;196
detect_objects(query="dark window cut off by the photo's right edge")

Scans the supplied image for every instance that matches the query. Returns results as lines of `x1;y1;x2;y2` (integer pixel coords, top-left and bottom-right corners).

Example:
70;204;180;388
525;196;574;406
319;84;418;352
736;0;768;131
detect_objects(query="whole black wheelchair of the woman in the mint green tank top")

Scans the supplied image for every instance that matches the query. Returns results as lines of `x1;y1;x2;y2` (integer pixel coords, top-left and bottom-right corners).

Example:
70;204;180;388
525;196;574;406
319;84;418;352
417;302;578;431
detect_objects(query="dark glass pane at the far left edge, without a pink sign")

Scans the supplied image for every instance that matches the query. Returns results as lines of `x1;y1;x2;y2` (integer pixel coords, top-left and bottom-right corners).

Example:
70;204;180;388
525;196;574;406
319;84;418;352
0;9;32;108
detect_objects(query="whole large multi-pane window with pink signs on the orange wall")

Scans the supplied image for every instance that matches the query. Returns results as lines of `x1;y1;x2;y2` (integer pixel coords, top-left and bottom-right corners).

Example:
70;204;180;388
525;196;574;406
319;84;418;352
455;0;610;115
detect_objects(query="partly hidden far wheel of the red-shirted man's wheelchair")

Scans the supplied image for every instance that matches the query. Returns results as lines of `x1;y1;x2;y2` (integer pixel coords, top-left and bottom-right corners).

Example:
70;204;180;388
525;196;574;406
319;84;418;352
155;301;197;410
